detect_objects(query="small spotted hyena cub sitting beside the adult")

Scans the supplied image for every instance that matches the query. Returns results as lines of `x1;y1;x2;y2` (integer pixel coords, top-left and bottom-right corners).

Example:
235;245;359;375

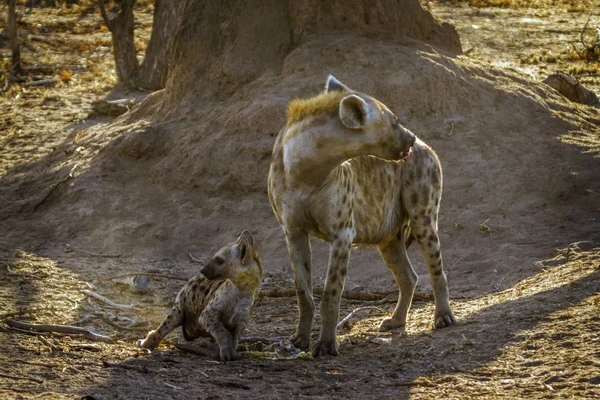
138;231;262;361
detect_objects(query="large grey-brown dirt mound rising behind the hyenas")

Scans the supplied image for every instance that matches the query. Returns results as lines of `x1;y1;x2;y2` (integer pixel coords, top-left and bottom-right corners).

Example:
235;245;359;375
0;2;600;295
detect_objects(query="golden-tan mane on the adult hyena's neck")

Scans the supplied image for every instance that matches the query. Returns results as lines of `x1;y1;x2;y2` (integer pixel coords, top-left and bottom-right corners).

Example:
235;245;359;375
287;90;348;126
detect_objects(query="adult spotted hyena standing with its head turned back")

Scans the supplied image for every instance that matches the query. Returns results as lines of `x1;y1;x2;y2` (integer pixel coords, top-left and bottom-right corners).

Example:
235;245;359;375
268;76;455;356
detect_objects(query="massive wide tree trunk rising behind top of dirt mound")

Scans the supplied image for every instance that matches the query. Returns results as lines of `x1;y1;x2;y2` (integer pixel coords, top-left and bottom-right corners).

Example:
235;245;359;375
167;0;462;105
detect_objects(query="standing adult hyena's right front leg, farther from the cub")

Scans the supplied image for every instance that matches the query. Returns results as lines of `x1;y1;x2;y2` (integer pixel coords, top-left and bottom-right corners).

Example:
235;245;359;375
312;237;352;357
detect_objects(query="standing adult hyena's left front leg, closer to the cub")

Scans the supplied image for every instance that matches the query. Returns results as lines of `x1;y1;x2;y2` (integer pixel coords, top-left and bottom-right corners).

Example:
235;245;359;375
286;232;315;350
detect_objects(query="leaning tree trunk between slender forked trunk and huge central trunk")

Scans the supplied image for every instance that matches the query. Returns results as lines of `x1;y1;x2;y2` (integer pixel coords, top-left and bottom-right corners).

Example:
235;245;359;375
137;0;179;90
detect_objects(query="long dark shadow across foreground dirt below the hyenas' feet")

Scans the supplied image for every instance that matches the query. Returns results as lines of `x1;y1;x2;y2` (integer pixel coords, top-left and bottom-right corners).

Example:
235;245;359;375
65;252;600;399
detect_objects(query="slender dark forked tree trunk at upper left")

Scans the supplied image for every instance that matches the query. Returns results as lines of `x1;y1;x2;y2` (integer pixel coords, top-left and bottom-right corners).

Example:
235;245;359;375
99;0;139;86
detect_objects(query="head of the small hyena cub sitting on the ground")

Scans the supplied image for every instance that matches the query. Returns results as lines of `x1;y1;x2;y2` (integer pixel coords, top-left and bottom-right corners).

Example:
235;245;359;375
200;231;262;290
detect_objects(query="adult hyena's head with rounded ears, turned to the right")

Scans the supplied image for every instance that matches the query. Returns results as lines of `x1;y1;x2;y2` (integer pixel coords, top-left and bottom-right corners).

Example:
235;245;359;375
325;75;416;161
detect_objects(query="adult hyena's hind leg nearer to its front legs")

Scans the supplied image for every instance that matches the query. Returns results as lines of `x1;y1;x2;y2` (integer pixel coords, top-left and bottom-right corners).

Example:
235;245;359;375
377;230;418;331
